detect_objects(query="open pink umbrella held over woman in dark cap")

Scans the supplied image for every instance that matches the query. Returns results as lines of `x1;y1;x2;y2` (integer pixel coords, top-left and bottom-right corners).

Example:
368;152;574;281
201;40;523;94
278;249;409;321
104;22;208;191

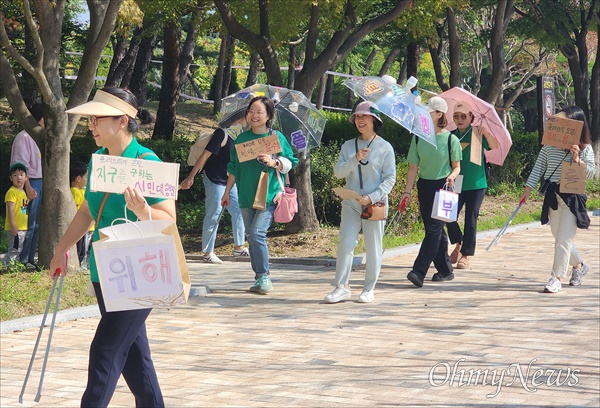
438;87;512;166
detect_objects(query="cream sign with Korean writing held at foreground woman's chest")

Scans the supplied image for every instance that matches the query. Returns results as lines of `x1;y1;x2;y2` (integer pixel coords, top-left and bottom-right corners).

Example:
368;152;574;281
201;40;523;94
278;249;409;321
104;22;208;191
88;154;179;200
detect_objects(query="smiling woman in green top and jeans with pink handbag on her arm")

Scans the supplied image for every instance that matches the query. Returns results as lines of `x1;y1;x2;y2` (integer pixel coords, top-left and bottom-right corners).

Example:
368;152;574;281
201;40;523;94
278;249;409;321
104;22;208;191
221;96;298;294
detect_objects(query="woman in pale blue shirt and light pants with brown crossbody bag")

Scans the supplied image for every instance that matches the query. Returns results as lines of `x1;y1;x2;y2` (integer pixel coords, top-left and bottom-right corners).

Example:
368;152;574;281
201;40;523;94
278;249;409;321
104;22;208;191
325;102;396;303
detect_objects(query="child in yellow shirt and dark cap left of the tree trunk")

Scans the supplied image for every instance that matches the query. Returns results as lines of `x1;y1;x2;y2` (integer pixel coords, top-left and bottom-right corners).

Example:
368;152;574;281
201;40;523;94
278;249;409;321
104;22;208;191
4;162;27;265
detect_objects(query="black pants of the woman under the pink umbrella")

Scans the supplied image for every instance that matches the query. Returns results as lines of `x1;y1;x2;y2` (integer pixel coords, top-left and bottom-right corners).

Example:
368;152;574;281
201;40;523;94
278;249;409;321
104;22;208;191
447;188;485;256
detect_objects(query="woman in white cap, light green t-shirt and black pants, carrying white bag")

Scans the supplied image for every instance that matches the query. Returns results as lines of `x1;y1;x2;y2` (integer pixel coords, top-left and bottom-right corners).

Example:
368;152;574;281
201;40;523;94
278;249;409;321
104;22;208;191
400;96;462;288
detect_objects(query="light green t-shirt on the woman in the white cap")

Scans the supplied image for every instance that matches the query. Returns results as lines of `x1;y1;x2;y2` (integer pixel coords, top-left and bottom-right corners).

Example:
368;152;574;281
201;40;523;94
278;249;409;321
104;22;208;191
406;131;462;180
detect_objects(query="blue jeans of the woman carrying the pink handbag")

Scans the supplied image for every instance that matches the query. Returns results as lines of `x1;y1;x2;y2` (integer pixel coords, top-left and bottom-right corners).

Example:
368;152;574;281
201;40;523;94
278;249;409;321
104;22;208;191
242;205;275;279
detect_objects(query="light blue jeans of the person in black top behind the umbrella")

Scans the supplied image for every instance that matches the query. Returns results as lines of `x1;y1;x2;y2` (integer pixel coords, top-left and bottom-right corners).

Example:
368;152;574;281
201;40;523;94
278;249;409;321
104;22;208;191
202;174;245;254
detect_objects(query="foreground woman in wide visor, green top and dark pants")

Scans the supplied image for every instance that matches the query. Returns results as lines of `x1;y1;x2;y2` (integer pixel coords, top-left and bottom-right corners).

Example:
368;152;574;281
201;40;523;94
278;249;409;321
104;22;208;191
50;87;176;407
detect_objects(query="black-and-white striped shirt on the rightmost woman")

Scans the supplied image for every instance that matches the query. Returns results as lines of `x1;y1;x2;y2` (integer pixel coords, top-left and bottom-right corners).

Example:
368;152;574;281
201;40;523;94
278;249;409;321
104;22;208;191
525;145;596;189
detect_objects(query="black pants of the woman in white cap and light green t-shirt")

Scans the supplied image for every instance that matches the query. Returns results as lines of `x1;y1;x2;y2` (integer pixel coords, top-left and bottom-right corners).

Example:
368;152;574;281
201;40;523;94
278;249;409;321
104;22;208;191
413;178;453;278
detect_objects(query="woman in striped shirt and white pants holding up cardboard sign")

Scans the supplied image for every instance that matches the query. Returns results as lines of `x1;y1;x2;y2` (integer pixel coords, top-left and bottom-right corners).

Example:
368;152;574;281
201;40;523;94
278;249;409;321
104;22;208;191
520;106;596;293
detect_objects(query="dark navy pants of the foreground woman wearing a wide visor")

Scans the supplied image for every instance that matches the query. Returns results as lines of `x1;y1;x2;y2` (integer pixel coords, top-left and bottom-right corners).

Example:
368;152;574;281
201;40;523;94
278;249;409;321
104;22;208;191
81;282;165;408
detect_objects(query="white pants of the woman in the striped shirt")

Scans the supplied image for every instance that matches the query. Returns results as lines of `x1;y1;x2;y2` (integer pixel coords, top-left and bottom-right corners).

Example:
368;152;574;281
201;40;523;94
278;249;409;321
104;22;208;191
549;195;581;278
